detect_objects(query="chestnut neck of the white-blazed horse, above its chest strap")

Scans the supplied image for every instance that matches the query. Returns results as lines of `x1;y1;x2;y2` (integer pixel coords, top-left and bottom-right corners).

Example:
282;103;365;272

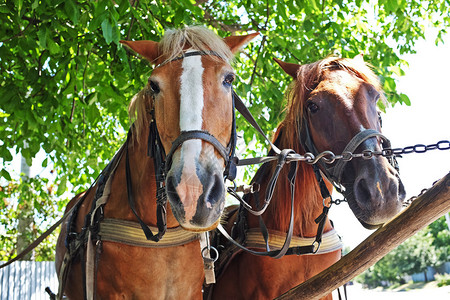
105;132;178;228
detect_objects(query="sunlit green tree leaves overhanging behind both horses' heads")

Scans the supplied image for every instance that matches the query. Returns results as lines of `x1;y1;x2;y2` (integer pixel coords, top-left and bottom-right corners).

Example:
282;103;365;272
0;0;450;258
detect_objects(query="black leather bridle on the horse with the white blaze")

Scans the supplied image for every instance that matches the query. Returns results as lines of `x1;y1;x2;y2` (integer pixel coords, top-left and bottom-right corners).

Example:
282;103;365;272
125;51;237;242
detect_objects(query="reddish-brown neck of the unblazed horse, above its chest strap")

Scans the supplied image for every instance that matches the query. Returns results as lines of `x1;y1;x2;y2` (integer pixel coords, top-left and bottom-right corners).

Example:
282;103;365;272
251;132;329;237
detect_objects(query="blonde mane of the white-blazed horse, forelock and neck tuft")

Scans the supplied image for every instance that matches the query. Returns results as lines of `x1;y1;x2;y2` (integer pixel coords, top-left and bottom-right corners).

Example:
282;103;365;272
128;26;234;142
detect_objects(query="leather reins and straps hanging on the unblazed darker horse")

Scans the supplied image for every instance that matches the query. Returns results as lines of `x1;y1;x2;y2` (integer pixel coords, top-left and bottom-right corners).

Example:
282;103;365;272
218;87;398;258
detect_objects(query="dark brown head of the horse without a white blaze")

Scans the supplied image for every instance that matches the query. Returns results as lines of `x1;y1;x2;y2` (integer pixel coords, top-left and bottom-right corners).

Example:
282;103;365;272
277;55;405;228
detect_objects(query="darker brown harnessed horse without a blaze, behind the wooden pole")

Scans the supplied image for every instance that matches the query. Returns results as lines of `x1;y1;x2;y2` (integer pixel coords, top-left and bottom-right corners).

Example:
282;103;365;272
212;57;405;300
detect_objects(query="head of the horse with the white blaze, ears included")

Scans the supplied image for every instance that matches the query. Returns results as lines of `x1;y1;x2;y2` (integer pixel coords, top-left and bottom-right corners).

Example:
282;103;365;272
122;27;257;231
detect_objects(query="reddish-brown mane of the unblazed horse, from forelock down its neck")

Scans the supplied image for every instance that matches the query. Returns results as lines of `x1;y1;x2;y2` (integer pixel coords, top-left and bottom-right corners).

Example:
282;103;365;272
269;57;385;234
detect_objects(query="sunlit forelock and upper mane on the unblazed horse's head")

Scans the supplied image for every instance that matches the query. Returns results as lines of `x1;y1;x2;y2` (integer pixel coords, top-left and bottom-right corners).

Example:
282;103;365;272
279;57;386;151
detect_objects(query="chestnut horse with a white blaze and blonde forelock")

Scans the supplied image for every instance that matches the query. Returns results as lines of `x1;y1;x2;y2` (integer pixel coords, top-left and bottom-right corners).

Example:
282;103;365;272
56;27;256;299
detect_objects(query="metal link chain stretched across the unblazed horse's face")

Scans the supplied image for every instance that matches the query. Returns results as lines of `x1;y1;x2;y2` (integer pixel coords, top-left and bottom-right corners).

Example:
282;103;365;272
287;140;450;165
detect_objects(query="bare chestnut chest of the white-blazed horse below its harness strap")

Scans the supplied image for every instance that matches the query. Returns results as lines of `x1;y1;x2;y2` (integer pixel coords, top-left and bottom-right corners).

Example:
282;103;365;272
97;241;204;299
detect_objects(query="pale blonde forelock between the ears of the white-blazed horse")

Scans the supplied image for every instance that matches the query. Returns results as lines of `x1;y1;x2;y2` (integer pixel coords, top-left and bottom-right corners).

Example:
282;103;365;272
159;26;234;64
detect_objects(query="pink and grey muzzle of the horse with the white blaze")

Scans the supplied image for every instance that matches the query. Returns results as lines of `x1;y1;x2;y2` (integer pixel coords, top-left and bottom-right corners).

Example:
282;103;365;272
166;140;225;231
